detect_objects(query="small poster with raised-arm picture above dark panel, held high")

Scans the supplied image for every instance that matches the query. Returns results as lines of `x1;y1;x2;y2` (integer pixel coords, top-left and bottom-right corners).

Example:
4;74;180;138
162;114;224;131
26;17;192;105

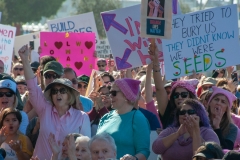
141;0;172;39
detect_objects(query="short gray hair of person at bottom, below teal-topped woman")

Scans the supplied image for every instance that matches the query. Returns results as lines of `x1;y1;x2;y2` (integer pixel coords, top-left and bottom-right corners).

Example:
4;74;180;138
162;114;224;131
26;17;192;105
88;132;117;152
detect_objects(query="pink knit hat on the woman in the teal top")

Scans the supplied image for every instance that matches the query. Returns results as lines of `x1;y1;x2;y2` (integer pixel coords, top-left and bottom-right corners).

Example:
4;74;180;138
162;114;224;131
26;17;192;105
114;78;141;102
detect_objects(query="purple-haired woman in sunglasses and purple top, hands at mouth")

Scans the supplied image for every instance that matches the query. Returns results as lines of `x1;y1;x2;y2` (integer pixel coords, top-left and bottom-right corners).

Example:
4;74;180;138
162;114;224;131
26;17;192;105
152;99;220;160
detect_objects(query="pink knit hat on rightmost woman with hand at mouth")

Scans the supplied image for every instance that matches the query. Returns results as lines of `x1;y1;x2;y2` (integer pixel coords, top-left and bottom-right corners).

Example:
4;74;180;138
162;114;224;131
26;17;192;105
208;86;237;108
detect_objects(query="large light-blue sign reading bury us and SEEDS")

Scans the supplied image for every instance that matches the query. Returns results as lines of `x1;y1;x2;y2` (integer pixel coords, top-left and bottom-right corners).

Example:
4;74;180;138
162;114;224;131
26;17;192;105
162;5;240;79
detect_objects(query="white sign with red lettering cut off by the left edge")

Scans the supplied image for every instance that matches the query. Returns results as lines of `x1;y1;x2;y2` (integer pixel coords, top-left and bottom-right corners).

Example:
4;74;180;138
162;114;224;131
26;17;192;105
0;24;16;74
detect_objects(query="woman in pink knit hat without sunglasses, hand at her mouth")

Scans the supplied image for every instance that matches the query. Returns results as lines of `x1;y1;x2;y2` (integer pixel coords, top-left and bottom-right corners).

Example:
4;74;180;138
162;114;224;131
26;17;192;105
208;86;238;150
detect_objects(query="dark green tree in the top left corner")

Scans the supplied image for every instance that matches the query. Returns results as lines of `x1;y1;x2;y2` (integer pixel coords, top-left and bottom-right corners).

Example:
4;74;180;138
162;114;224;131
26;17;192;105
0;0;64;24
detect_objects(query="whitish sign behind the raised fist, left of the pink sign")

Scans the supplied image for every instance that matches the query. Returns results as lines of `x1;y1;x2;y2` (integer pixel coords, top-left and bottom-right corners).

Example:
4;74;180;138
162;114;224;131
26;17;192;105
14;32;40;62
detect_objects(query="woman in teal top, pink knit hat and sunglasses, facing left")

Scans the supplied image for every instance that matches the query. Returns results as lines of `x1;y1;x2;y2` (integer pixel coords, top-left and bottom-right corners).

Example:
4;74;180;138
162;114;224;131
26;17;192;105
97;78;150;160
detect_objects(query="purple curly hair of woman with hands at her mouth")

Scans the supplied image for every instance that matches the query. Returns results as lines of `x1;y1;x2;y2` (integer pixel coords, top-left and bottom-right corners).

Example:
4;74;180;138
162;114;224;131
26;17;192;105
173;98;211;128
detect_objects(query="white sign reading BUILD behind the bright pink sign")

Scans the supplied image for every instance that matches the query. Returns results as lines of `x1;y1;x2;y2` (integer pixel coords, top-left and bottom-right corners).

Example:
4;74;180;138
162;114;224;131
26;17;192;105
48;12;99;43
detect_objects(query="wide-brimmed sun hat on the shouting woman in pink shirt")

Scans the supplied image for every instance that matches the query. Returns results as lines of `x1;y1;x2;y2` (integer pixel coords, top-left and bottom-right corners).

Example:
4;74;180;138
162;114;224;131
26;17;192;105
44;78;79;100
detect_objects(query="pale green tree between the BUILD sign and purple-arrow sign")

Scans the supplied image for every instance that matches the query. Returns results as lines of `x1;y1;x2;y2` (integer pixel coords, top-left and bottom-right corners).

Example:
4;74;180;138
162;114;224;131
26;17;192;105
73;0;121;37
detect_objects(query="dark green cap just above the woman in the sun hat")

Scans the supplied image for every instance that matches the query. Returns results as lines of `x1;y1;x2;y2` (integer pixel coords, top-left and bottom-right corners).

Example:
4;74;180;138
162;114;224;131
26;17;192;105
43;61;64;76
